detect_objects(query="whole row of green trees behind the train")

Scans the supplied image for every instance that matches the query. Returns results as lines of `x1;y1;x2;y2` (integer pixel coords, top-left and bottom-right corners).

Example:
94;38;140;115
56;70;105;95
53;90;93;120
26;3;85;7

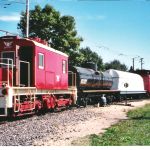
17;4;127;71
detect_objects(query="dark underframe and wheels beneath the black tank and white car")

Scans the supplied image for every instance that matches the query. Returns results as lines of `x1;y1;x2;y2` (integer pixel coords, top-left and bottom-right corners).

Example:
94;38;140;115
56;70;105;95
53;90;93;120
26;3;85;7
77;90;149;107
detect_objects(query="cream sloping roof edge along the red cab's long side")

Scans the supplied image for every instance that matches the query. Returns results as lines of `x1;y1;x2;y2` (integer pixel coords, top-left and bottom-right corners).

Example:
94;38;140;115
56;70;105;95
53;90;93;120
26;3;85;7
25;38;68;57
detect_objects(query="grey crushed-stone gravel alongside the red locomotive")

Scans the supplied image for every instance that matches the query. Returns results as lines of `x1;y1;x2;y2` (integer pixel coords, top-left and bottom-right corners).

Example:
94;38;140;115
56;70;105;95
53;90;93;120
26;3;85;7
0;106;100;146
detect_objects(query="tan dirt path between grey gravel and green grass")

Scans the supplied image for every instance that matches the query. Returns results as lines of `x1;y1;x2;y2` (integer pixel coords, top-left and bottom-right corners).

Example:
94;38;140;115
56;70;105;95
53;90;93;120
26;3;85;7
35;100;150;146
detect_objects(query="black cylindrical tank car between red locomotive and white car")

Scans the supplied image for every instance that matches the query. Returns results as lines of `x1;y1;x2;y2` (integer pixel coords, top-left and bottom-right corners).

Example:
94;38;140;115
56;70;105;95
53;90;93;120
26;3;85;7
69;63;117;106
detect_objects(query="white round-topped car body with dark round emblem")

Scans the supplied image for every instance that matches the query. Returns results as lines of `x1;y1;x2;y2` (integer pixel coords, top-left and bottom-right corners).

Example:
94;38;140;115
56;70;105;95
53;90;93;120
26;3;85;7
106;69;145;94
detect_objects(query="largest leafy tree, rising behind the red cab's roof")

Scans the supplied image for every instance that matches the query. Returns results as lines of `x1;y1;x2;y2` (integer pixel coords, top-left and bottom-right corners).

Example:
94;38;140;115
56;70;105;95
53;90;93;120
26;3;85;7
18;4;82;63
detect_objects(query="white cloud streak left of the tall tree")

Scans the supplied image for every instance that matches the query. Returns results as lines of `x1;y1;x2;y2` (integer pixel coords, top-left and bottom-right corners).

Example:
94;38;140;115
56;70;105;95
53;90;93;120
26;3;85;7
0;14;20;22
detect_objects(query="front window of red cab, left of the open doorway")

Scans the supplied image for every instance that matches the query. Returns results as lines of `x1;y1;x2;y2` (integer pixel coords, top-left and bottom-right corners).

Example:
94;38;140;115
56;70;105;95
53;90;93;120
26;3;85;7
1;51;15;65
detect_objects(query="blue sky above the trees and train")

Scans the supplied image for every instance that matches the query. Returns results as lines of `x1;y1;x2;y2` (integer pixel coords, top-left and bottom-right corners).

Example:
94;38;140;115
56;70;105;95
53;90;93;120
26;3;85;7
0;0;150;70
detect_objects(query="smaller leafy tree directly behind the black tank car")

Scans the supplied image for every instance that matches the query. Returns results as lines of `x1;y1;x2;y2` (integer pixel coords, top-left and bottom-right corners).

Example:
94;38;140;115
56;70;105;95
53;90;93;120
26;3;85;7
80;47;104;70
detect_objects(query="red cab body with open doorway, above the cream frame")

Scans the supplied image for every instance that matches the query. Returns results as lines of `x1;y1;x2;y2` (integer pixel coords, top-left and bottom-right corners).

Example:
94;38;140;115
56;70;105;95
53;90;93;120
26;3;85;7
0;36;68;89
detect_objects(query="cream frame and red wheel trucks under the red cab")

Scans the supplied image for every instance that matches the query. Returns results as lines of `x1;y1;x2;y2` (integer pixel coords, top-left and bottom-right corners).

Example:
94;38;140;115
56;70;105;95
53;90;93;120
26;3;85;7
0;87;77;117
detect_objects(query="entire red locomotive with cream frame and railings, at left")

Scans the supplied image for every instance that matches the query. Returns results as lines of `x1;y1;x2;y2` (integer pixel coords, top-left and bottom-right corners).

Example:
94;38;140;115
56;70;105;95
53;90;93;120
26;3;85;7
0;36;77;117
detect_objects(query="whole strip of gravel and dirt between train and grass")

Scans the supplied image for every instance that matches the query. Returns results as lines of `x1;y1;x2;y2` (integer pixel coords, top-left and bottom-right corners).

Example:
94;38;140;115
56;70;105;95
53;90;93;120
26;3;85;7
0;100;150;146
